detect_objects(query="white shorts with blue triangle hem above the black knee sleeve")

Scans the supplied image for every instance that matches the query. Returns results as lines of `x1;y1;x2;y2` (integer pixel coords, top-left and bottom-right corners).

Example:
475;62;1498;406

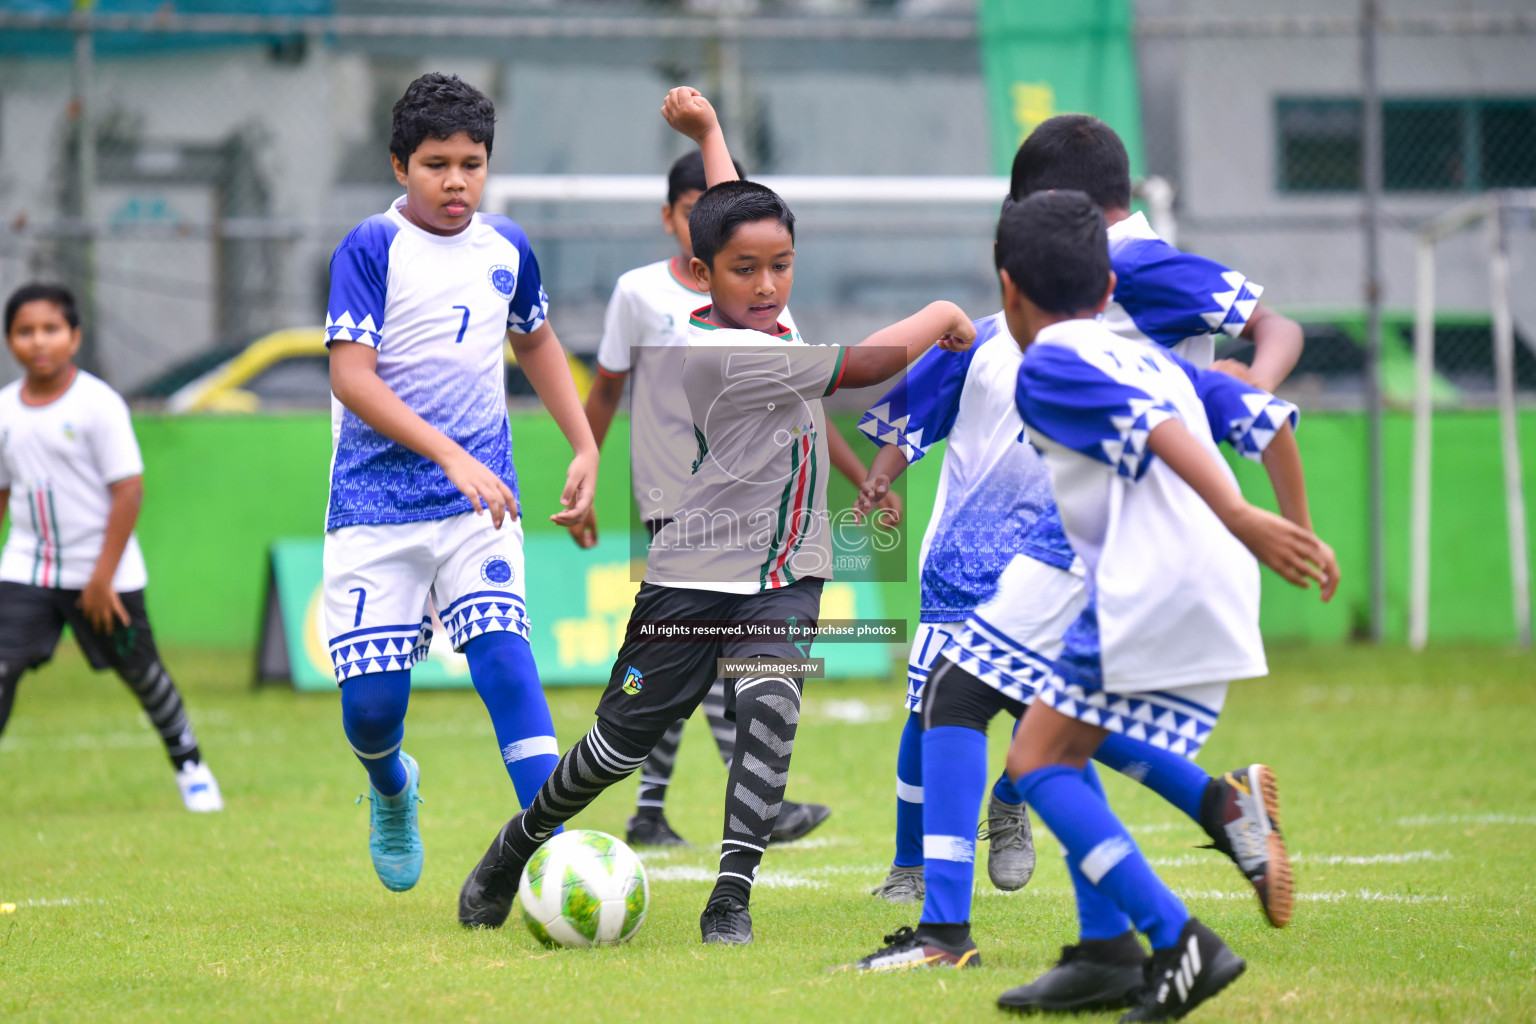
943;554;1087;703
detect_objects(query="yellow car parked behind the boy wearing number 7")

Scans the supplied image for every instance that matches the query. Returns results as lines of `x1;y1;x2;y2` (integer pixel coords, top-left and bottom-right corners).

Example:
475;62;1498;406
162;327;591;413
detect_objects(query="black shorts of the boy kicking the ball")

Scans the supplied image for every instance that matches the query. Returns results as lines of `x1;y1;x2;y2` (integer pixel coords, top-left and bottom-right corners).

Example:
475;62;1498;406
598;577;822;734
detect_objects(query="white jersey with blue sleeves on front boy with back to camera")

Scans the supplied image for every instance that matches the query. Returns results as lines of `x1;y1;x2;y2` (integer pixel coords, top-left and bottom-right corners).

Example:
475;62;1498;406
1017;319;1296;694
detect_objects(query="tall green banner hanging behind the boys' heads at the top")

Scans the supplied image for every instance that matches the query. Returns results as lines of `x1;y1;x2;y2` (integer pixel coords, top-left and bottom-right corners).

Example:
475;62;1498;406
980;0;1141;178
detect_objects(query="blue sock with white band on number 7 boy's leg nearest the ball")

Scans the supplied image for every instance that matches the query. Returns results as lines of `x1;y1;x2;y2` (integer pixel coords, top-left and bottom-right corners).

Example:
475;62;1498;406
464;631;561;808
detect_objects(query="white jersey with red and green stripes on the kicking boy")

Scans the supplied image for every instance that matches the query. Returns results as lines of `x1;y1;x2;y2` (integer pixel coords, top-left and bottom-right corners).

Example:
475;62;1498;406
645;307;848;594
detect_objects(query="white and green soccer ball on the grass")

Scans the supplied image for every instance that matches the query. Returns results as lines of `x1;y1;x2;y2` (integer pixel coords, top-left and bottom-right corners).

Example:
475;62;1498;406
518;829;651;947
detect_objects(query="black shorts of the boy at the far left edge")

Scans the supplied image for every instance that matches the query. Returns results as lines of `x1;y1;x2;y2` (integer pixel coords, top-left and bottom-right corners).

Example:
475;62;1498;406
0;582;158;672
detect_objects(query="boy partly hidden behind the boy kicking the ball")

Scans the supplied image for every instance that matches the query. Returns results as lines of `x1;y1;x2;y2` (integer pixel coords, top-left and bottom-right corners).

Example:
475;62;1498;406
570;149;841;846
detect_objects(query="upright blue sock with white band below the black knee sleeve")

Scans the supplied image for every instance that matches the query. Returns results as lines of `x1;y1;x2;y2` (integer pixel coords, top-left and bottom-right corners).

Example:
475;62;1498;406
920;725;986;924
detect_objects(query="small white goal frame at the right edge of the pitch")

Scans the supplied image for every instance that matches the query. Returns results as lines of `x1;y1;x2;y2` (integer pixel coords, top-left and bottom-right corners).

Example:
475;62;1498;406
1409;190;1536;651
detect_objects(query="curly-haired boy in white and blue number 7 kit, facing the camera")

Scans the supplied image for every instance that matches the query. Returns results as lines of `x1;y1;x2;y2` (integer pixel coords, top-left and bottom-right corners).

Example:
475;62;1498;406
324;74;598;892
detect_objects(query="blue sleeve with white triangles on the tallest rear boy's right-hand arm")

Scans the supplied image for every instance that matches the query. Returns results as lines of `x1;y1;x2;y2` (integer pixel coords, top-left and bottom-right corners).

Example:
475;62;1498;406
1104;213;1264;367
